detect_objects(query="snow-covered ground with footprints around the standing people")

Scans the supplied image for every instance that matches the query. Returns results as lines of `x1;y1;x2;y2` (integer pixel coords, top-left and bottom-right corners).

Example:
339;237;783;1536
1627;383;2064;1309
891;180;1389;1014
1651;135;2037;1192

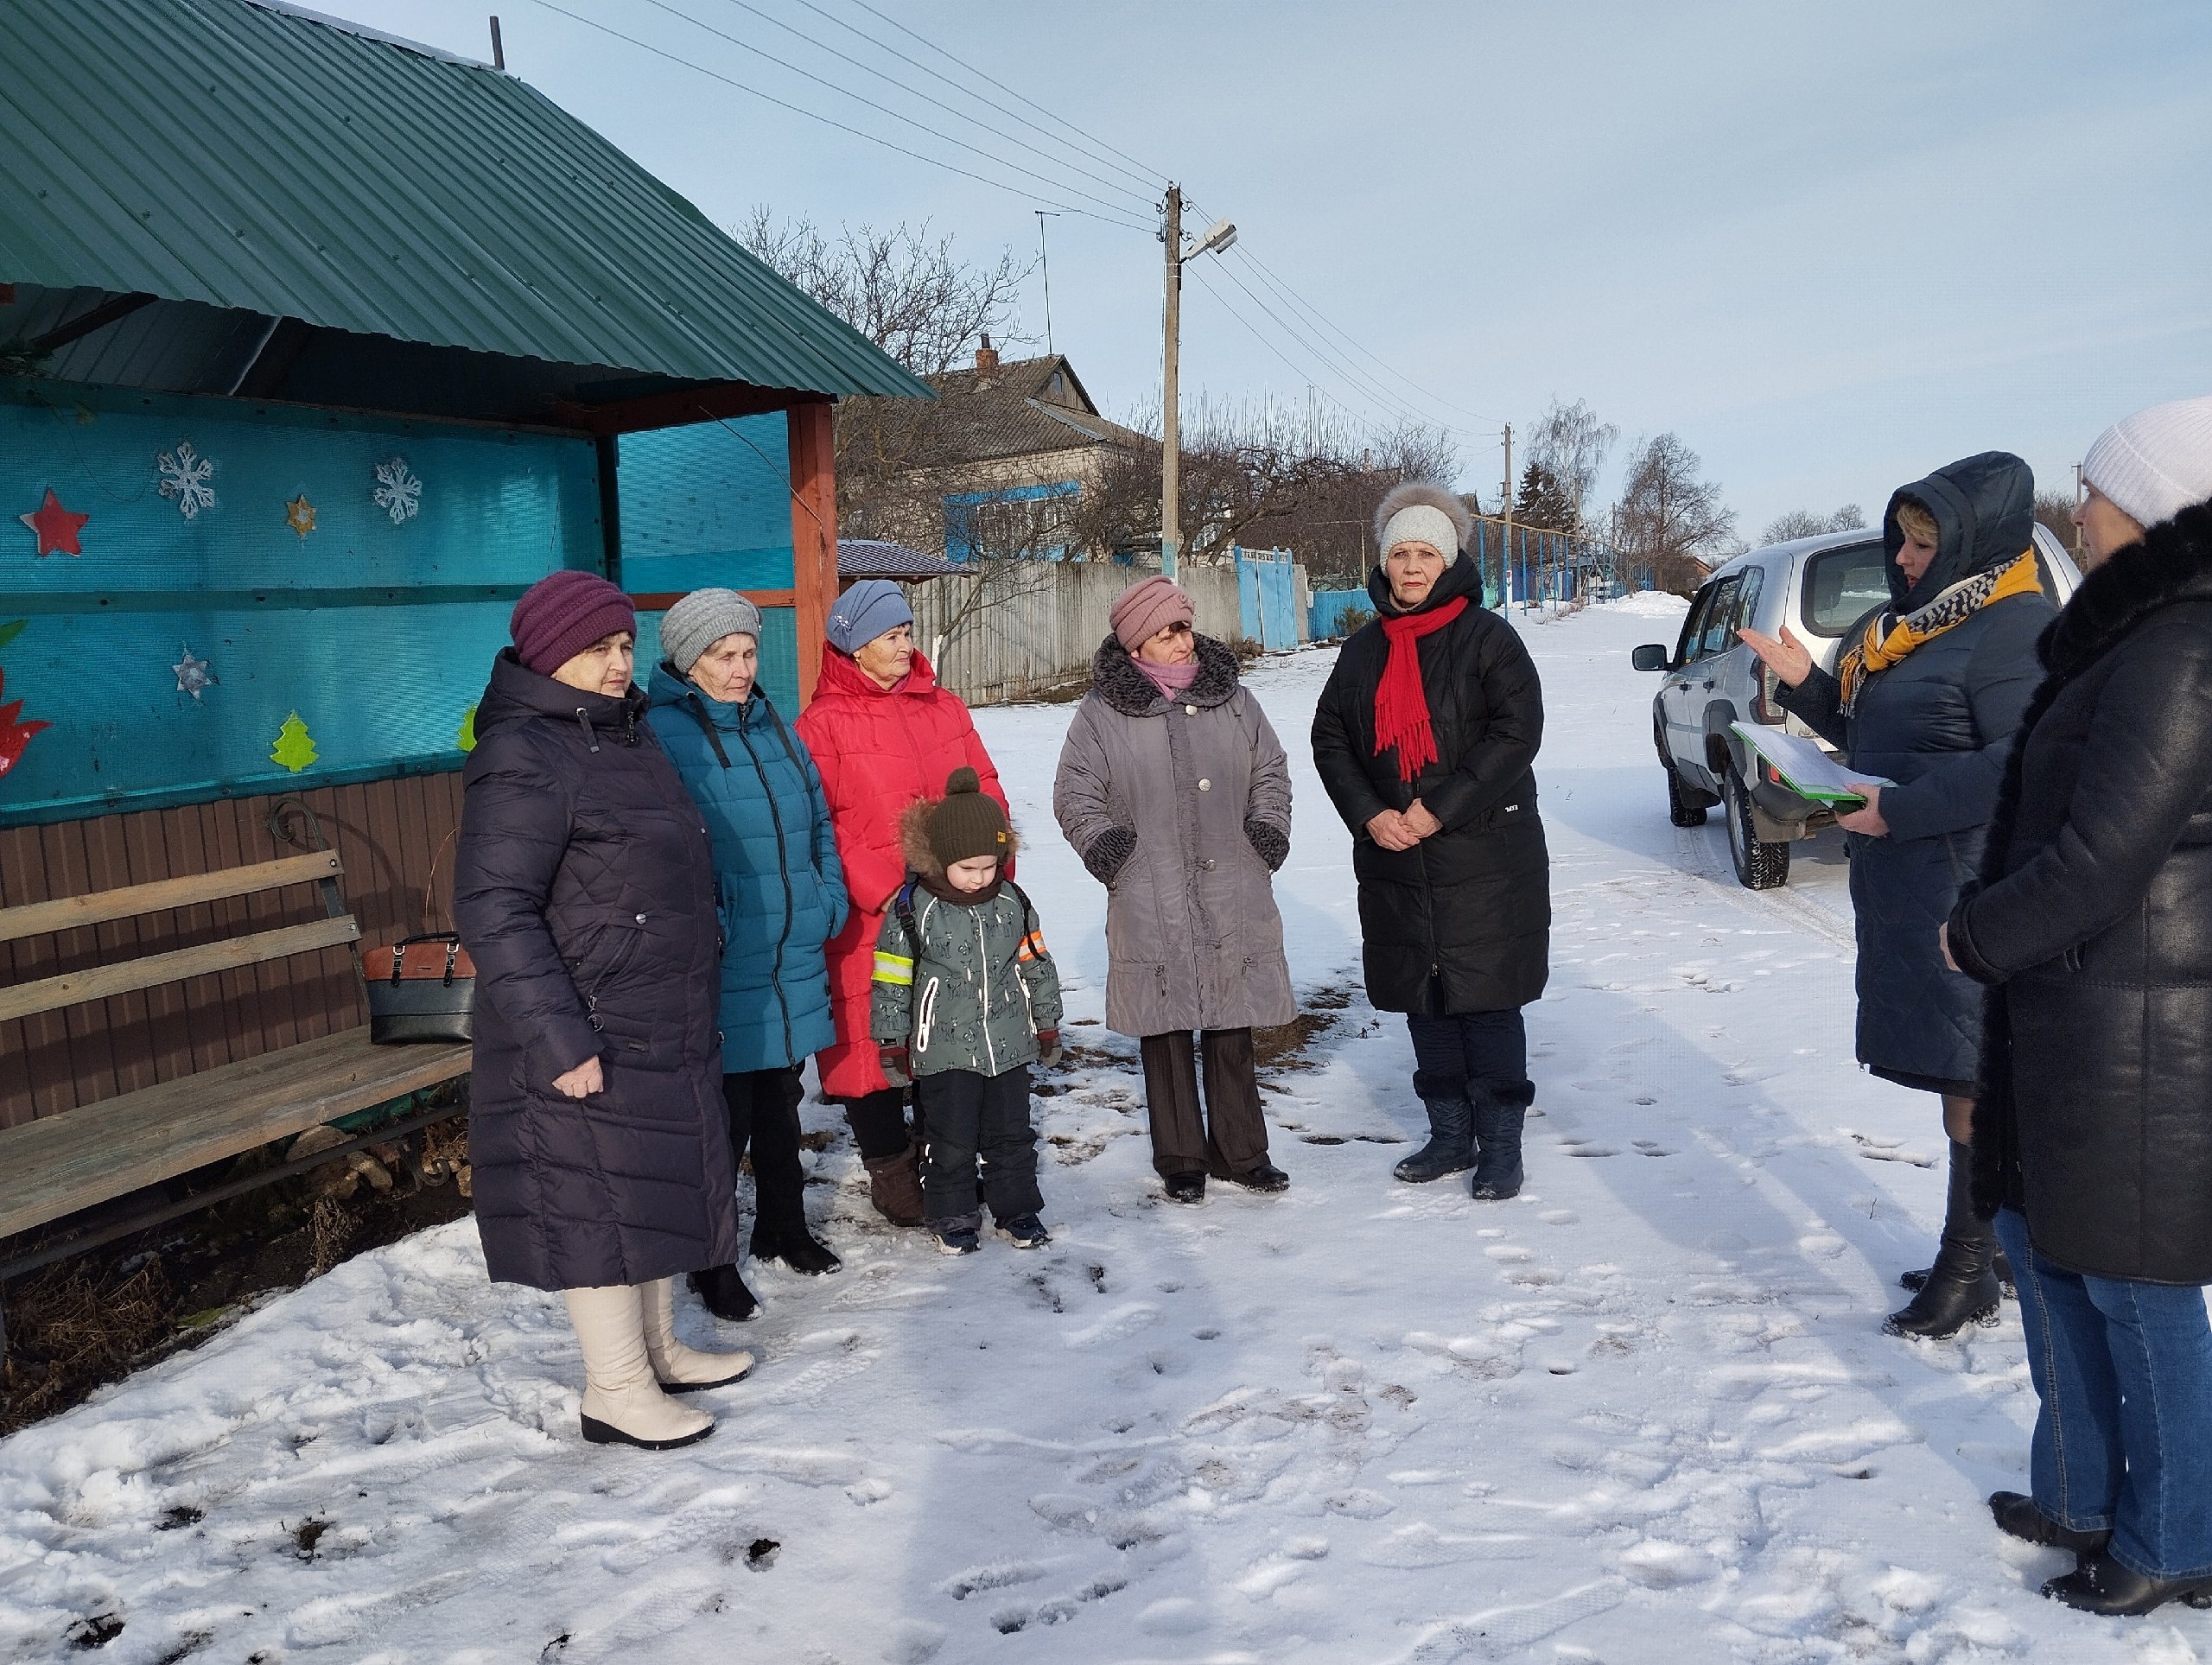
0;600;2212;1665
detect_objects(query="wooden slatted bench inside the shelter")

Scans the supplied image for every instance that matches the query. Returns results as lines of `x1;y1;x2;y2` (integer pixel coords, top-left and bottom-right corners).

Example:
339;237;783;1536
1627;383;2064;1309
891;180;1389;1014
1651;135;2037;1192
0;851;469;1349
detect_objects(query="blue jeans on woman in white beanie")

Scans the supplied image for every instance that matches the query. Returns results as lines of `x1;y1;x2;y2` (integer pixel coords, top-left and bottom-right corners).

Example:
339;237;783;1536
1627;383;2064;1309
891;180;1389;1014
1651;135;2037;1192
1998;1210;2212;1579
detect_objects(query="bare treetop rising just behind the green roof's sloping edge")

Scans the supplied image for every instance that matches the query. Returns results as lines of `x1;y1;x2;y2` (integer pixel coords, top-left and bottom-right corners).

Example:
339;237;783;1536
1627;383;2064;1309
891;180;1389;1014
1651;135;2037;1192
734;206;1035;376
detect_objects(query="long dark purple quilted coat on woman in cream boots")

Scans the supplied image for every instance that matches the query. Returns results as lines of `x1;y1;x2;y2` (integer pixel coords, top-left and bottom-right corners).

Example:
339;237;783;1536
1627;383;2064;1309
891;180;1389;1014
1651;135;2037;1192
454;648;736;1289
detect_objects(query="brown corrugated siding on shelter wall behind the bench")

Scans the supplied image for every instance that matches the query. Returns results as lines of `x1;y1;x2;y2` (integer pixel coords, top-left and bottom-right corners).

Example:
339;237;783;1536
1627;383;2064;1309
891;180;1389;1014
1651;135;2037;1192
0;774;460;1128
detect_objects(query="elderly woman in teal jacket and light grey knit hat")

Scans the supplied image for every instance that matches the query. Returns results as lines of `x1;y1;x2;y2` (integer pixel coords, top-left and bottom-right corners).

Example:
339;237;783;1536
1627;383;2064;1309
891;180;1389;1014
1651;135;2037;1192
646;590;847;1320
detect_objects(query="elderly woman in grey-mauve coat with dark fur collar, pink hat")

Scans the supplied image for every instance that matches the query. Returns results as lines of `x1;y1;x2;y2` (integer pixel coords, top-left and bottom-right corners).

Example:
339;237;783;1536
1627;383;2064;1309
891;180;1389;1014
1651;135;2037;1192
1053;577;1299;1203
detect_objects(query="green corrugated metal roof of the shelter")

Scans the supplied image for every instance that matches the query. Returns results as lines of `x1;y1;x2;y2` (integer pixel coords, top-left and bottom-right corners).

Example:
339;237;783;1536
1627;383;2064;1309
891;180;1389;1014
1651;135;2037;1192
0;0;929;398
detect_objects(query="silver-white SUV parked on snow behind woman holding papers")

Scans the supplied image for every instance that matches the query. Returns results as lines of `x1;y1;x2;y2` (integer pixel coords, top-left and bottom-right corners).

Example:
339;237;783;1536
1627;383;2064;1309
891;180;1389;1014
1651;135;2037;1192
1632;526;2082;891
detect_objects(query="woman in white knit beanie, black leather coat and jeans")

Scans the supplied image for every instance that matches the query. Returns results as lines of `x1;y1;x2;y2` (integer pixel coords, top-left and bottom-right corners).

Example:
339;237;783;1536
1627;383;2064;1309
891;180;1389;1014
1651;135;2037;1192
1942;398;2212;1614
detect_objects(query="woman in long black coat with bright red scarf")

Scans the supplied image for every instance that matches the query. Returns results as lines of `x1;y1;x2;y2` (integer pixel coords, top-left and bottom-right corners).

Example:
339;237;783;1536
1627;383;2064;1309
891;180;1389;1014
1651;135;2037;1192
1314;480;1551;1201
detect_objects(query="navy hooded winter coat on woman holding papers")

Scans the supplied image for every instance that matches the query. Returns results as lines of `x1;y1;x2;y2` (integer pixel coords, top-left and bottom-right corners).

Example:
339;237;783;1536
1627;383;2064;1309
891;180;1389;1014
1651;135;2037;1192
1781;451;2050;1092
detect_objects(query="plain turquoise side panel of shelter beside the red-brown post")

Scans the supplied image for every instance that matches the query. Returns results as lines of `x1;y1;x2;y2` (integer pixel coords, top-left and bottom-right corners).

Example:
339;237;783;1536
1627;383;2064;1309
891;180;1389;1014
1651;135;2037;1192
615;411;798;716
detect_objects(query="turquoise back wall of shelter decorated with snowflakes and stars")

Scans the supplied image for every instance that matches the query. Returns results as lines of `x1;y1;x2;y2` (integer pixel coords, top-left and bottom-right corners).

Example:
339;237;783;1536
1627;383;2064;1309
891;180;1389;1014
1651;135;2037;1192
0;380;606;825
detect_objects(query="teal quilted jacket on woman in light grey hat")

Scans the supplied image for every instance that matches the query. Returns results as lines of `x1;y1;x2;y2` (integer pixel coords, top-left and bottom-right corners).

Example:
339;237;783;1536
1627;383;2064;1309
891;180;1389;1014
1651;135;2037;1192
646;661;847;1075
